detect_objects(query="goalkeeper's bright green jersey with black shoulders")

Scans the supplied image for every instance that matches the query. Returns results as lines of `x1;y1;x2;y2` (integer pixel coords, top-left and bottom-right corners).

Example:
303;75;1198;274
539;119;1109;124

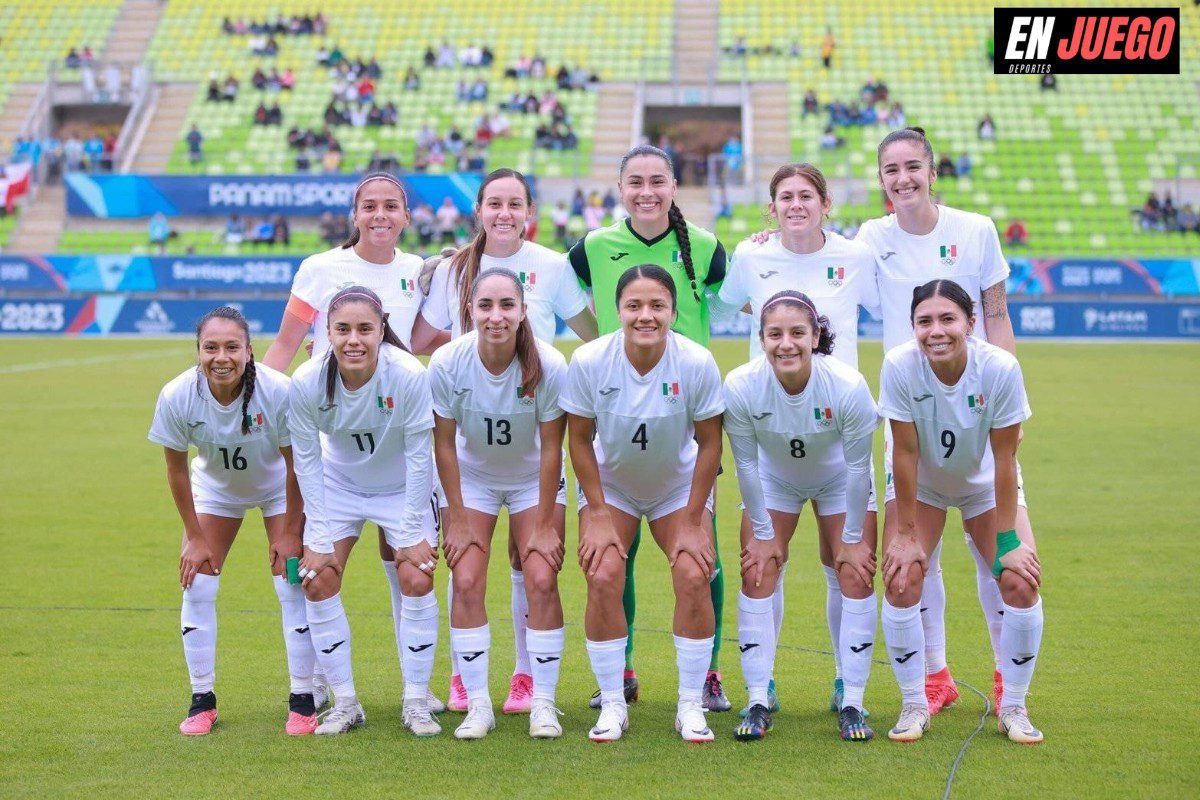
568;219;725;347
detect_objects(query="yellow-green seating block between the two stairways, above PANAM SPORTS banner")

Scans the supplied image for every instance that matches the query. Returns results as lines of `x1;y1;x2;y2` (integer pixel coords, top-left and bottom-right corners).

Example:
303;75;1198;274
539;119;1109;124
149;0;672;175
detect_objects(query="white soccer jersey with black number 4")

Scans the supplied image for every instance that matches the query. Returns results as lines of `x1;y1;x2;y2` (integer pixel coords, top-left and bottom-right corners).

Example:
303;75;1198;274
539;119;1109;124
559;331;725;505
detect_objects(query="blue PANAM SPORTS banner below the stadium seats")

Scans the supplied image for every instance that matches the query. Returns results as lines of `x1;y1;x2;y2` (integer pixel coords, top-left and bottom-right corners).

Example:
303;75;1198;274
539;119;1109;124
66;173;480;219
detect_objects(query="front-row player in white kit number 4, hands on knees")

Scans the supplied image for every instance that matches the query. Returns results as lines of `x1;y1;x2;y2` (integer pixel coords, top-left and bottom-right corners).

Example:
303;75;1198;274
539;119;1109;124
559;264;724;742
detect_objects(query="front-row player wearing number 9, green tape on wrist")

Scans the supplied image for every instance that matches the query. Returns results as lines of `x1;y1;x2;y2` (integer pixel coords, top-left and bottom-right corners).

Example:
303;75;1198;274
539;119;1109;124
880;279;1043;744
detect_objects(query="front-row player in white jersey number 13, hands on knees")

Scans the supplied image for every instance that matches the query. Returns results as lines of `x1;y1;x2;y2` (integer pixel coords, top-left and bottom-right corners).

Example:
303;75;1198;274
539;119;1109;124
430;269;566;739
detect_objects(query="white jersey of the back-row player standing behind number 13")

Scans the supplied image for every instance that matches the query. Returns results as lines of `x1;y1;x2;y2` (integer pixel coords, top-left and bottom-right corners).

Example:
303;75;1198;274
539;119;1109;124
421;241;588;342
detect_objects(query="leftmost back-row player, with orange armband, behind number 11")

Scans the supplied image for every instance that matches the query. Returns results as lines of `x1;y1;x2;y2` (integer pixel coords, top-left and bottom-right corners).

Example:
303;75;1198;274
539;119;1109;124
263;173;445;712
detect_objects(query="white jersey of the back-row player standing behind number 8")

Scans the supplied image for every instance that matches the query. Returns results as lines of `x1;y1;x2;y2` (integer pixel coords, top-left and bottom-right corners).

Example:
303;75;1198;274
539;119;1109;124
718;230;880;369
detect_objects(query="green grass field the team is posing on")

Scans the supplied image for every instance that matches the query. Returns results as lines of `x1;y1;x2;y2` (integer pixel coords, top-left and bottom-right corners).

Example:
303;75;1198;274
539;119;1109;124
0;339;1200;798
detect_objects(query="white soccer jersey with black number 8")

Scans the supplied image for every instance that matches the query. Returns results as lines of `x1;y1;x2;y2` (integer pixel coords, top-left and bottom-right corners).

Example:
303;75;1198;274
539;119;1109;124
725;355;881;494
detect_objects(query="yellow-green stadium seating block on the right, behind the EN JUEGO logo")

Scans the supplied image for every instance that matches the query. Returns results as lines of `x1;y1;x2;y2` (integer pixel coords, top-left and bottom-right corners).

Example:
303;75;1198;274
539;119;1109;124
720;0;1200;255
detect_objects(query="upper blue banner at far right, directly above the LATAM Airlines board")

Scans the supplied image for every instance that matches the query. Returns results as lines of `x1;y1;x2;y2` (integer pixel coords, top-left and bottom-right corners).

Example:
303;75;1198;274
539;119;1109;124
1008;258;1200;297
